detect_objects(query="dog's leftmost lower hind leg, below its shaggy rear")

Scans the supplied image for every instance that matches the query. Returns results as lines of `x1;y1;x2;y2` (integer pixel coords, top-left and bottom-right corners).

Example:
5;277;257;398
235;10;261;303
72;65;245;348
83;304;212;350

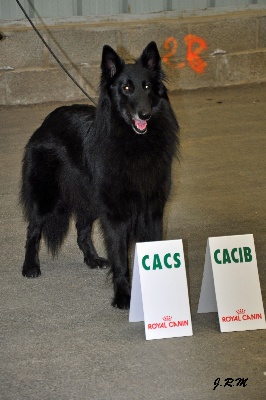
22;218;42;278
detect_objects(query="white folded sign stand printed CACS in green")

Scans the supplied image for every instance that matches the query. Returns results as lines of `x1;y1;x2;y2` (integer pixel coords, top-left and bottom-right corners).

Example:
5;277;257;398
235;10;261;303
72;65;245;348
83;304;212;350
129;240;193;340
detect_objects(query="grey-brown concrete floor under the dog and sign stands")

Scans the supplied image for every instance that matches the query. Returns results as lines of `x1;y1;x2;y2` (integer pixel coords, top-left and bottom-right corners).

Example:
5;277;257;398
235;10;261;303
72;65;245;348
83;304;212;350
0;84;266;400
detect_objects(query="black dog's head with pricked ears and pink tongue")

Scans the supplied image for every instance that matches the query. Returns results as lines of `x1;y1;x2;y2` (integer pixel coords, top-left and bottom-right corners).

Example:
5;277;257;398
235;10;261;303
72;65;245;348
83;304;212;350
101;42;168;134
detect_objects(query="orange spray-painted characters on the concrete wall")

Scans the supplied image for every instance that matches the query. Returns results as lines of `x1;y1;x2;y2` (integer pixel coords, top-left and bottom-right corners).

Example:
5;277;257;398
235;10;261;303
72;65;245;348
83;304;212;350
162;34;208;74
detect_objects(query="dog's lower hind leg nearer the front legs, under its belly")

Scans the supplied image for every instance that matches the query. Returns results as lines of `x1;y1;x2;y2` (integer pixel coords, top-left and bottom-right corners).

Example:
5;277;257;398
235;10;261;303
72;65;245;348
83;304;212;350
76;217;108;268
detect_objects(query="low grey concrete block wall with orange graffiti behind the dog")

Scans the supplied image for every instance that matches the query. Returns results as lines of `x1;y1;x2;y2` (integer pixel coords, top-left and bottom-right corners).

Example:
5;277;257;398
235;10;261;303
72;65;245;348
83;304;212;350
0;9;266;105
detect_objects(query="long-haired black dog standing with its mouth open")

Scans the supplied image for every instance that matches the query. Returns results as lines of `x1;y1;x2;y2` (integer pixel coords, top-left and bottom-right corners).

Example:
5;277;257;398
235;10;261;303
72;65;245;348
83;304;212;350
21;42;179;308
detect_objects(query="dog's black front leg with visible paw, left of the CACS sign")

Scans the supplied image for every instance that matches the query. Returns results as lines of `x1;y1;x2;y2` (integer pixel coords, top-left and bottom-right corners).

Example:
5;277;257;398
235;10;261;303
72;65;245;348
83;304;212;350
101;217;130;309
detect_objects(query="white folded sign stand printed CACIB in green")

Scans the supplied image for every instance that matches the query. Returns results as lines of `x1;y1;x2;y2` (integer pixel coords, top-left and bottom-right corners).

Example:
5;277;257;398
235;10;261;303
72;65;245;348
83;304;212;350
198;235;266;332
